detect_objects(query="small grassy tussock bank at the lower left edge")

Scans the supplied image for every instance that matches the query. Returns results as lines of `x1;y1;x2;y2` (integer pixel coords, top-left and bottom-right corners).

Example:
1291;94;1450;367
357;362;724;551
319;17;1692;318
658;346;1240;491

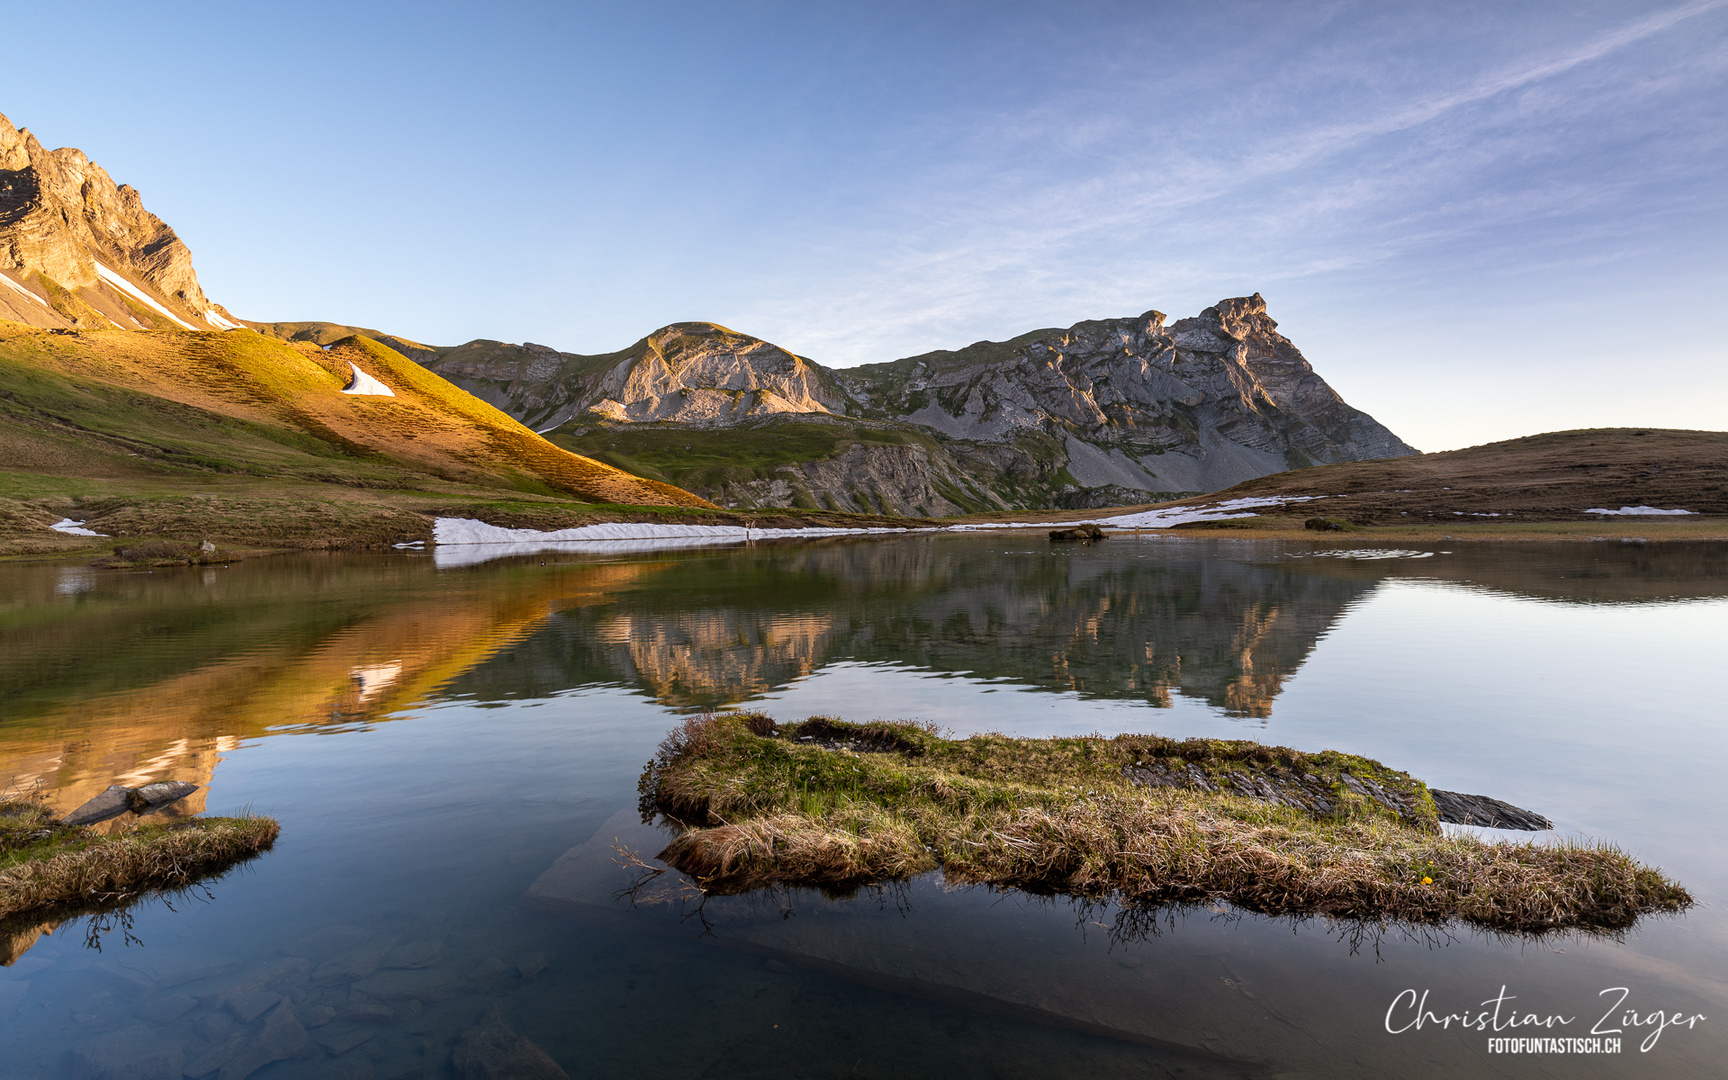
0;802;280;921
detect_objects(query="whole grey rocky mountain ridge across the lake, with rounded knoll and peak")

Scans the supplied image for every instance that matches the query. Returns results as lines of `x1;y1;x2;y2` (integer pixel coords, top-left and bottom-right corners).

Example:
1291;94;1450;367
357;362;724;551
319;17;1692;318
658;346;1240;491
415;294;1415;515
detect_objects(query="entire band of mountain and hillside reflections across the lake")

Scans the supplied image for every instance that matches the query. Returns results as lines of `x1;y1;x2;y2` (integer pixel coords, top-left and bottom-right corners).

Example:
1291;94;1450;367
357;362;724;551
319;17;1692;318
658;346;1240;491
0;537;1728;814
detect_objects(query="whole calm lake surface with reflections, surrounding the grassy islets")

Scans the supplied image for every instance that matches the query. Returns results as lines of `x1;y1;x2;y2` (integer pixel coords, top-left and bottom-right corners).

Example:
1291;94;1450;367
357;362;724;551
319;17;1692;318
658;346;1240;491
0;536;1728;1080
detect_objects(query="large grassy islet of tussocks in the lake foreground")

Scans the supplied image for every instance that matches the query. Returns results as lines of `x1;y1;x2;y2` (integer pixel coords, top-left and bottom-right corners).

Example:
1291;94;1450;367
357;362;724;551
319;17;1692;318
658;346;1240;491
641;714;1693;933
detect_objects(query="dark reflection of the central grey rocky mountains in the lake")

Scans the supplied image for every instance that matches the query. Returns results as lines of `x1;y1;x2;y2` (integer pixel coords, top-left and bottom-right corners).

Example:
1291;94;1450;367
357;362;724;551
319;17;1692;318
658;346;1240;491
438;544;1374;717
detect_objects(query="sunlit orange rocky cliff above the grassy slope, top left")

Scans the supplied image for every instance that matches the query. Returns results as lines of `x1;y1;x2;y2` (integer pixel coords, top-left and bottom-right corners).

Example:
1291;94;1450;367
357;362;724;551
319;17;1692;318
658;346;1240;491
0;116;238;330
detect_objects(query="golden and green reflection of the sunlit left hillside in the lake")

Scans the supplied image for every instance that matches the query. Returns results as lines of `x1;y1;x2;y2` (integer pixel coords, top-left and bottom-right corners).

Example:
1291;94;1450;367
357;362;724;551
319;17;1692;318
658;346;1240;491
0;560;667;814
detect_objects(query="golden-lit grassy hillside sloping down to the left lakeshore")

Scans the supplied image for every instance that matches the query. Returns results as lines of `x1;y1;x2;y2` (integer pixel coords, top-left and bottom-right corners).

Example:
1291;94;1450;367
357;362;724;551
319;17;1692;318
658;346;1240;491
0;323;722;550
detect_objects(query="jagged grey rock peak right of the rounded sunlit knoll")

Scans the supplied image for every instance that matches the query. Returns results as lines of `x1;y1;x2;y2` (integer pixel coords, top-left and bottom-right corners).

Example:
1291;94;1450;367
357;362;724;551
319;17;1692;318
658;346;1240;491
843;294;1415;492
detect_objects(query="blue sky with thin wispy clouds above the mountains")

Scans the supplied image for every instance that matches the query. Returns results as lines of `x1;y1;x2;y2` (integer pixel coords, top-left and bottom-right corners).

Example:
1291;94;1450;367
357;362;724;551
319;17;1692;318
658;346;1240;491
0;0;1728;449
